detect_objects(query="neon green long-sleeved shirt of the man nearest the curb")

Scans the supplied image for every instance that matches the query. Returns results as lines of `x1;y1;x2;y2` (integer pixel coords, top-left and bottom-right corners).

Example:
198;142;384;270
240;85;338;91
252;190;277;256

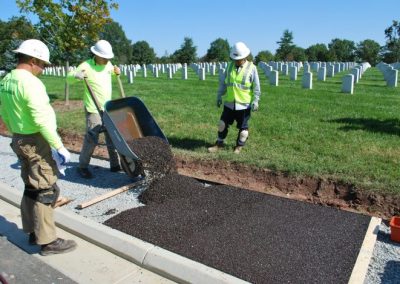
0;69;63;149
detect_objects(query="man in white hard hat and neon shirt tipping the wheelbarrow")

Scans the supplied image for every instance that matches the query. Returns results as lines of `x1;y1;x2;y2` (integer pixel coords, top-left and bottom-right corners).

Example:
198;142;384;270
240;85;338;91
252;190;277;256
67;40;121;179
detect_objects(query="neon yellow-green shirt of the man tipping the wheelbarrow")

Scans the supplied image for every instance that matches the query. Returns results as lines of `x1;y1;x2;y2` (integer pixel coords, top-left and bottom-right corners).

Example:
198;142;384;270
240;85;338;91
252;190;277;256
67;58;115;113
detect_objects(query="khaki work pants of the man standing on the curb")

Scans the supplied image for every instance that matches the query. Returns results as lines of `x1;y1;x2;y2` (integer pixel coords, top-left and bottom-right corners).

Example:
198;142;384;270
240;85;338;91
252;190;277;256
11;133;58;245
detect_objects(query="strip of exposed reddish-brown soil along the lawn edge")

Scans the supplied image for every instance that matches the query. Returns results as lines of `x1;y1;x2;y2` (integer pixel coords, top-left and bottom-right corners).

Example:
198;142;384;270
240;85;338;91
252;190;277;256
0;115;400;220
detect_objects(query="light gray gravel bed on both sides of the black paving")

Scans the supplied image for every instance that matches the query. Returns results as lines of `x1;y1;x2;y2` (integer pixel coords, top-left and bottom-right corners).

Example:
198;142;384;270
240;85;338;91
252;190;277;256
0;136;400;284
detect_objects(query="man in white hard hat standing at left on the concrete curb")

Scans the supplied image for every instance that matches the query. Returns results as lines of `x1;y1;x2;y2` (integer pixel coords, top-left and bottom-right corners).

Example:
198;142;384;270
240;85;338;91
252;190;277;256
0;39;76;255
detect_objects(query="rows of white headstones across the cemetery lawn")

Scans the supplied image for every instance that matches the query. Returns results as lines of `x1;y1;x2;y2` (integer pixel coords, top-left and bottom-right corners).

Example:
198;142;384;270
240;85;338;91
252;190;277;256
44;61;400;94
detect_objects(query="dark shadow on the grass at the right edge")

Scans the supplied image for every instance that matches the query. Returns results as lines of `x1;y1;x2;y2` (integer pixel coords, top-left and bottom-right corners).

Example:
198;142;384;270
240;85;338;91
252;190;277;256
326;117;400;136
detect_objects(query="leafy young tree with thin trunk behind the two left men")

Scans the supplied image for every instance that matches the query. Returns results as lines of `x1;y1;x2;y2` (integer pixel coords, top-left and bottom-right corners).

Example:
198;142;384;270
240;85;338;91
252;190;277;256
16;0;118;104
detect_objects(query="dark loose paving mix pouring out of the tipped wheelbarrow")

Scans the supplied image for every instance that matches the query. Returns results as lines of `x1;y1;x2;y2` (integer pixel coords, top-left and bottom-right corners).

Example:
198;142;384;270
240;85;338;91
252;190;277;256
128;136;176;178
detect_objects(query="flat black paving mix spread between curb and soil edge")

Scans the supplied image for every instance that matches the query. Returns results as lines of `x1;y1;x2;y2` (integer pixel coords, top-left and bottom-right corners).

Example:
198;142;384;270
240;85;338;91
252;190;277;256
105;136;370;283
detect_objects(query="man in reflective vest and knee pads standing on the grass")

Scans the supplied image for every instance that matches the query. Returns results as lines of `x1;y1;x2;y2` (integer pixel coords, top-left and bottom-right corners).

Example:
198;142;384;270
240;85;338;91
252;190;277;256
208;42;261;154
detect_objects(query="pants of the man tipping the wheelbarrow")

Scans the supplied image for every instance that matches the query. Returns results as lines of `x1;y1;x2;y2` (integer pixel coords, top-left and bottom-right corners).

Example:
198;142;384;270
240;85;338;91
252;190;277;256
79;111;120;168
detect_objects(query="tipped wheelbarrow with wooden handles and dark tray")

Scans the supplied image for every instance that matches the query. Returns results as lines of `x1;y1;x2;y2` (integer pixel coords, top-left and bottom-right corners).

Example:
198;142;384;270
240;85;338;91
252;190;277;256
84;78;168;178
